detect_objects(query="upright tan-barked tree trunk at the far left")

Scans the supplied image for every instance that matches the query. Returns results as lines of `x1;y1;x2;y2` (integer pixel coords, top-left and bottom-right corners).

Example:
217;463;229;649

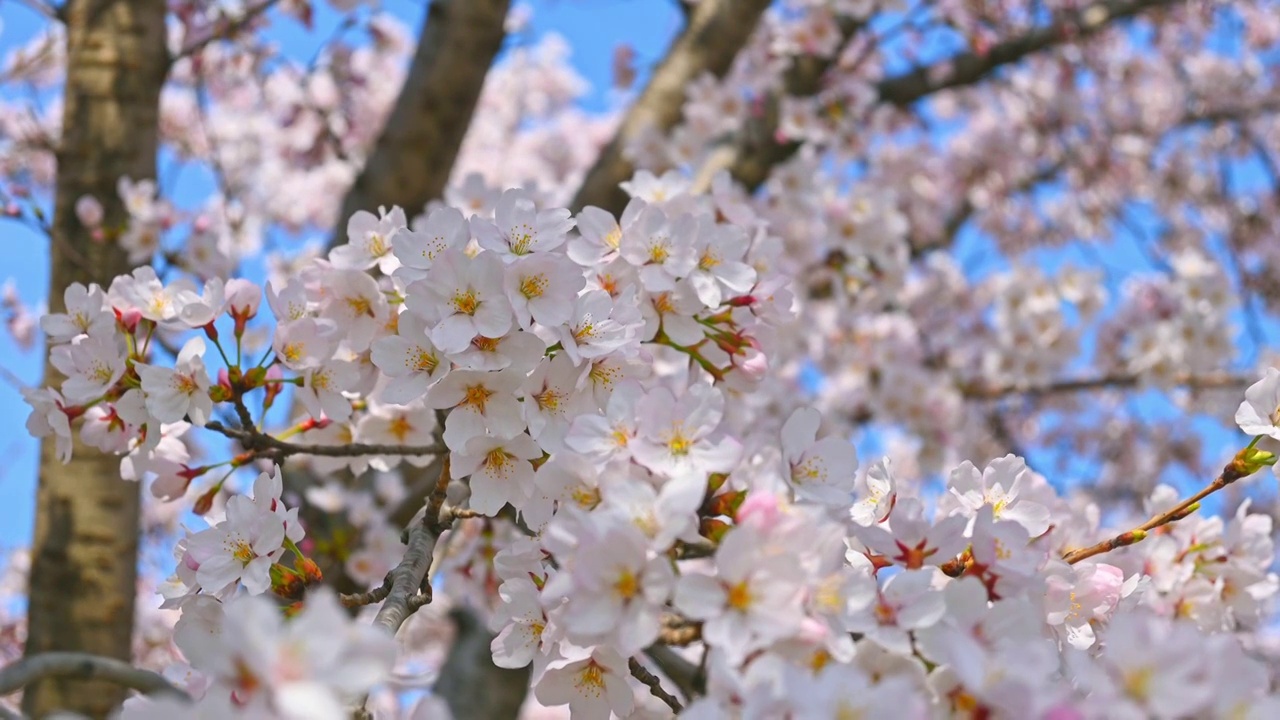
23;0;166;717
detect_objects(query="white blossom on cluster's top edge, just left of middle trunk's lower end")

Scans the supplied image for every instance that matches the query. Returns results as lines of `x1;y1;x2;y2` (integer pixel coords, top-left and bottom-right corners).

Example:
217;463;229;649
471;190;573;263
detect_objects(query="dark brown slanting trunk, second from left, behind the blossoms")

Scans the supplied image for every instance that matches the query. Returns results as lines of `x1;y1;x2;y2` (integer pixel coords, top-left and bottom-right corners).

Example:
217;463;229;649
332;0;511;242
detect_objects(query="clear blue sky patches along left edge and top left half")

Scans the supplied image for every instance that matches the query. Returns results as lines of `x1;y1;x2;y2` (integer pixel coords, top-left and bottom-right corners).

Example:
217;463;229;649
0;0;681;547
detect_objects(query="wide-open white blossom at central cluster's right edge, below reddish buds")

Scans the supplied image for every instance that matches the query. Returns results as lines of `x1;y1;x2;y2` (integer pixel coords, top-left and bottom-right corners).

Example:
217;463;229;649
631;383;742;477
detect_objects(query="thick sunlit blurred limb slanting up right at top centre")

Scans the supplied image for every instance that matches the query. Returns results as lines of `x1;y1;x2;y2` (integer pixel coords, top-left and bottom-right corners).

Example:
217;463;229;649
571;0;769;214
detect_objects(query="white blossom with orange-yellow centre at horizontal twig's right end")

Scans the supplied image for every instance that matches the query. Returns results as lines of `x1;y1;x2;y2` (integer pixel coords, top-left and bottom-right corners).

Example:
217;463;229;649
449;433;543;516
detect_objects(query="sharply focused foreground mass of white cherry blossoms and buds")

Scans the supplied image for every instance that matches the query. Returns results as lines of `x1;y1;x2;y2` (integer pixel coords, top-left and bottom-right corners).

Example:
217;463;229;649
28;172;1280;717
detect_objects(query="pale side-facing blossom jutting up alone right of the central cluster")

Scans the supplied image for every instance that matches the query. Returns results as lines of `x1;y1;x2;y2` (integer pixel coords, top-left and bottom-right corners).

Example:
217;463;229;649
782;407;858;505
